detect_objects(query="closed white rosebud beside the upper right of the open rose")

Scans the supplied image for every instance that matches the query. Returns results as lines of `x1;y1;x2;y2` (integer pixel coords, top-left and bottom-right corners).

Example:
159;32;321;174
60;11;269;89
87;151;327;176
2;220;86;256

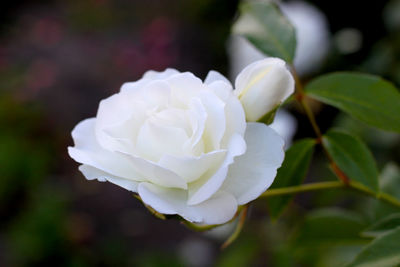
235;57;294;121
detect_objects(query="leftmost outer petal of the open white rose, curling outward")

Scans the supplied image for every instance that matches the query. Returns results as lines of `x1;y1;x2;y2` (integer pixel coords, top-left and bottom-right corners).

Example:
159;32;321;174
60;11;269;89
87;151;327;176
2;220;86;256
68;118;144;181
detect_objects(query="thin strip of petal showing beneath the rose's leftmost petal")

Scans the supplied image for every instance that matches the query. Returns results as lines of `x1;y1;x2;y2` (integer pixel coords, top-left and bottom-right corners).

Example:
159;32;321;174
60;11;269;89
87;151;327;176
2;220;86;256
79;164;138;192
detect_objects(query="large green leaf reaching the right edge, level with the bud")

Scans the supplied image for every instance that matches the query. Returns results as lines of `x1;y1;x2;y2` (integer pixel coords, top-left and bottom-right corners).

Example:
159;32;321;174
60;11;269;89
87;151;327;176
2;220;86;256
306;72;400;132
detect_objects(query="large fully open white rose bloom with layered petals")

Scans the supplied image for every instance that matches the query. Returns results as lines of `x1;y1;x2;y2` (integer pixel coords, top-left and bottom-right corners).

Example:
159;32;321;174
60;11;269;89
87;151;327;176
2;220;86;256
68;69;284;224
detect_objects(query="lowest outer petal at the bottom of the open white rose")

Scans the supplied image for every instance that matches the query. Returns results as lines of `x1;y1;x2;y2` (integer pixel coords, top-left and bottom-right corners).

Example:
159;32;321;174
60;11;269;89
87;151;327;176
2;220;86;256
138;183;237;224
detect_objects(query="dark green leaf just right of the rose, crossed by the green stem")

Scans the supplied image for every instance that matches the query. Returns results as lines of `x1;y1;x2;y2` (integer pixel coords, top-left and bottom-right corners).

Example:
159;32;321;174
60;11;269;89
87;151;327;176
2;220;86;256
268;139;315;219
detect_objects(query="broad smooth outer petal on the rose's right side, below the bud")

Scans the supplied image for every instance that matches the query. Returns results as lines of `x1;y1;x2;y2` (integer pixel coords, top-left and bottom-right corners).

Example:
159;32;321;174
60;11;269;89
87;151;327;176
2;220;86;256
221;123;285;205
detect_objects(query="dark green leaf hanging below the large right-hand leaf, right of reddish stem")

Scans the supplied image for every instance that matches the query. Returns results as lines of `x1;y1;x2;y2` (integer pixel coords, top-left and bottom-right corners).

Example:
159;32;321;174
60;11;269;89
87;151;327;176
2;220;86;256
322;130;379;192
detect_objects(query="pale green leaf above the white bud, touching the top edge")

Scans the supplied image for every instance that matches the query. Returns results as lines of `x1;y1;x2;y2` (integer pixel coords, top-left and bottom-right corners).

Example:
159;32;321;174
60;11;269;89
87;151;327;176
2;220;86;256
233;2;296;63
